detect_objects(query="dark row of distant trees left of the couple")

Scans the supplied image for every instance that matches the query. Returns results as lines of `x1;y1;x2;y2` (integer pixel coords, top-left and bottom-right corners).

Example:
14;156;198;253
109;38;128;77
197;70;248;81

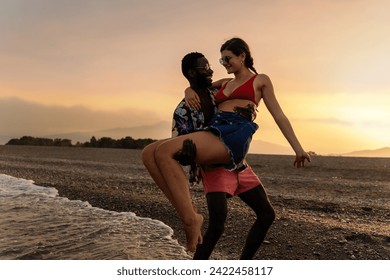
6;136;157;149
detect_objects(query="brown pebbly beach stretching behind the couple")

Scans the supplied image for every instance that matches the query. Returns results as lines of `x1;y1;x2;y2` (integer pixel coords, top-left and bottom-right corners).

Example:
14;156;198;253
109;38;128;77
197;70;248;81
0;146;390;260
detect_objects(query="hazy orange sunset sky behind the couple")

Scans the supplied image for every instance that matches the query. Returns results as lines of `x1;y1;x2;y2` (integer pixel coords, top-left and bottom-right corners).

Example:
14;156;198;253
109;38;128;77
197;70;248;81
0;0;390;154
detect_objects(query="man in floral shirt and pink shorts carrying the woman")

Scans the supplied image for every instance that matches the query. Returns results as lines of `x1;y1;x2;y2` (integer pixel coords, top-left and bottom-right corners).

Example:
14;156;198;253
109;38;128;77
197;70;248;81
143;52;275;259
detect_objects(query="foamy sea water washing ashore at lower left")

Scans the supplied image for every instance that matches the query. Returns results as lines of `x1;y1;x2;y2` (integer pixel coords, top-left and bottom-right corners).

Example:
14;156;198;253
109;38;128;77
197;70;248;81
0;174;190;260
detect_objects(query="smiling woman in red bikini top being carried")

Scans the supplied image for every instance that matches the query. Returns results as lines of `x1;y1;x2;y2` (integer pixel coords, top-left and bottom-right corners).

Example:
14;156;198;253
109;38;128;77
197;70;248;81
145;38;310;252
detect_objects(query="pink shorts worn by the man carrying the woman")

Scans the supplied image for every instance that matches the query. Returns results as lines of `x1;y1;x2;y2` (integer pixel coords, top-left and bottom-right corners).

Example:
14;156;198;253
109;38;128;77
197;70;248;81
201;166;261;196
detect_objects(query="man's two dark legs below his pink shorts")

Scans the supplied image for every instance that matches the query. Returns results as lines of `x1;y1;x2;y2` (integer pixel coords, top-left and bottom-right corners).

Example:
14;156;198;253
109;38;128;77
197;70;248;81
194;185;275;260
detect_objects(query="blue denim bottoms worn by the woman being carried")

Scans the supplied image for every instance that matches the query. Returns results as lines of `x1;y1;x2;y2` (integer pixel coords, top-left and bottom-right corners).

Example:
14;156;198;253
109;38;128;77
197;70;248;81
204;111;259;170
